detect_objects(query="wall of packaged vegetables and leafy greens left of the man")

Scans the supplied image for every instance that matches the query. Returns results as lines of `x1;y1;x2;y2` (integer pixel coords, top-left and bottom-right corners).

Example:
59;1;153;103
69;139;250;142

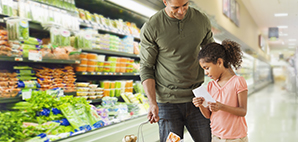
0;0;149;142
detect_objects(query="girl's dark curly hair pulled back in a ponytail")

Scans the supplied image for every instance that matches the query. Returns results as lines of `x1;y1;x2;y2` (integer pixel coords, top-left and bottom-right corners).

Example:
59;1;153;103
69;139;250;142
198;39;243;70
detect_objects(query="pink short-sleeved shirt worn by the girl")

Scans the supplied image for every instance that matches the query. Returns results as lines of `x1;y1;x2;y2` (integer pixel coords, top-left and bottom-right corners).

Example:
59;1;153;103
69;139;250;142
207;75;247;139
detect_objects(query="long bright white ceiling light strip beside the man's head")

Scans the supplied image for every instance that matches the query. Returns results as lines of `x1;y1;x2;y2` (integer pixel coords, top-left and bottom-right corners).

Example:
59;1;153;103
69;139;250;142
107;0;157;17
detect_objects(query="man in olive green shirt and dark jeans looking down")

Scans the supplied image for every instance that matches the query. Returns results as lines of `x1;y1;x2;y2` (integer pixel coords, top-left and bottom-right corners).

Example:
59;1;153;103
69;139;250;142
140;0;214;142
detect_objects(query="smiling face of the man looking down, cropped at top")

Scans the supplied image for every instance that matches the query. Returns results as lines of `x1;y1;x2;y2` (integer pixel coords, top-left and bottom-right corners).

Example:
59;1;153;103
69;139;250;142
163;0;189;20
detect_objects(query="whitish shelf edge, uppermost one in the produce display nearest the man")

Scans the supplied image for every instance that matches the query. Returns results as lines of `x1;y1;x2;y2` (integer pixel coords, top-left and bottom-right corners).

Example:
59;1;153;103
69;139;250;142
79;19;140;41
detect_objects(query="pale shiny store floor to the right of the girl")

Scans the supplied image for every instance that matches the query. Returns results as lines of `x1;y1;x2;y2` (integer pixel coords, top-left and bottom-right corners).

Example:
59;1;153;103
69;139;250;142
184;82;298;142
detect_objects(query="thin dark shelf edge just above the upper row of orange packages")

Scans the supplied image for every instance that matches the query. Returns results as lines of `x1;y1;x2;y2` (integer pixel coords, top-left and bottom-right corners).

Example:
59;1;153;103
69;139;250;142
82;49;140;59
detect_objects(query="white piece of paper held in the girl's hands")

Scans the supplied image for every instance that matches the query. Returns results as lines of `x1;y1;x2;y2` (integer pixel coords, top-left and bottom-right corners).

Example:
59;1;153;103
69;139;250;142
192;86;216;107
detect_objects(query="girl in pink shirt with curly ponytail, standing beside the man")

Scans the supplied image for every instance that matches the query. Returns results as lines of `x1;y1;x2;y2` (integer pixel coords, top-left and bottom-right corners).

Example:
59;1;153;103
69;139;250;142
193;40;248;142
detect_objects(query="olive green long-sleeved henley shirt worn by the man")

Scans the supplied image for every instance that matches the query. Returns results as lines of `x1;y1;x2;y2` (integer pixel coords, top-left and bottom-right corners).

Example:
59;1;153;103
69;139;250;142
140;7;214;103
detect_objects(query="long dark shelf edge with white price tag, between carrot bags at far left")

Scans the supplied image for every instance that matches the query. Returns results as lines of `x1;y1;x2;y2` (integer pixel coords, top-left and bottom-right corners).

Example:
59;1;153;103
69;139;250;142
0;56;81;64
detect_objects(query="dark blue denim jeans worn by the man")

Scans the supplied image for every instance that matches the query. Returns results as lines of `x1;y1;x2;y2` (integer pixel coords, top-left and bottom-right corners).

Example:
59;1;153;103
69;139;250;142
158;102;211;142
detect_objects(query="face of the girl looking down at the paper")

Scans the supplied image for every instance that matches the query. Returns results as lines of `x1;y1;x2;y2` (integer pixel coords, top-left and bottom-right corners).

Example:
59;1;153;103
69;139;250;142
199;58;223;80
